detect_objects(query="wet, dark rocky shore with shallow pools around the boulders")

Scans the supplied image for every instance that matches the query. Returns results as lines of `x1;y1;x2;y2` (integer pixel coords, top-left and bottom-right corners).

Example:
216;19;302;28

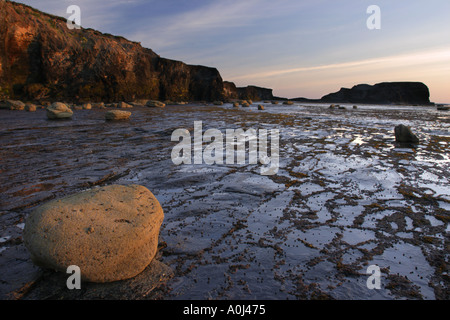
0;104;450;299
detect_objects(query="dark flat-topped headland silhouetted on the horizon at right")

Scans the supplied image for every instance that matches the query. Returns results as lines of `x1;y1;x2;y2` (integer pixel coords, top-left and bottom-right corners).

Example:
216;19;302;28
321;82;430;104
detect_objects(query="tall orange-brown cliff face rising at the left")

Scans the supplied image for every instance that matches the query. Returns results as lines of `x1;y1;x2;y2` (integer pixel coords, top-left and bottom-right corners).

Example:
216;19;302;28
0;1;223;101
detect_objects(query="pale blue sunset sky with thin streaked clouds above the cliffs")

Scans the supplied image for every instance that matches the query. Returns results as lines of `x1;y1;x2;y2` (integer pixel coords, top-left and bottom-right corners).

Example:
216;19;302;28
16;0;450;103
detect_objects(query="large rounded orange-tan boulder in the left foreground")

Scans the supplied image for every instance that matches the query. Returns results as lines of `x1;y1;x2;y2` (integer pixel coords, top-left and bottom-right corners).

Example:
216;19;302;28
23;185;164;283
